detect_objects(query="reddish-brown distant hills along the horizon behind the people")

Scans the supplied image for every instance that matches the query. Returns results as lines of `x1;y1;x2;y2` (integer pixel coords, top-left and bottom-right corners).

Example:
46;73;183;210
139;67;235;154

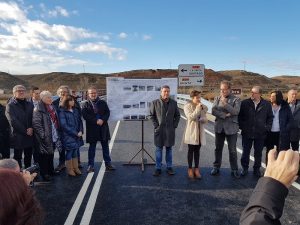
0;69;300;98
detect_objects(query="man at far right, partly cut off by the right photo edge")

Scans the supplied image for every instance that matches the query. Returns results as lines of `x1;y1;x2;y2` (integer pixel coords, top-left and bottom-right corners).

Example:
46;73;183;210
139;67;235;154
287;89;300;151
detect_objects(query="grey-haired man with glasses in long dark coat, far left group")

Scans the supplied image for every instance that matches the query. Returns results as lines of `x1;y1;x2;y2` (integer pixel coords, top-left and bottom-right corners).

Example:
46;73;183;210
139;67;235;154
5;85;33;168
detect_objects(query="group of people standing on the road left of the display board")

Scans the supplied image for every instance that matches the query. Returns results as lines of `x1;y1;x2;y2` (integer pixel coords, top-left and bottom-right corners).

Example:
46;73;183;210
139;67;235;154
0;85;115;181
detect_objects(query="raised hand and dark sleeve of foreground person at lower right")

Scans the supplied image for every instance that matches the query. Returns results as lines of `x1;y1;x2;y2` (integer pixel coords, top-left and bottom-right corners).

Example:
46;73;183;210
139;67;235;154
240;150;299;225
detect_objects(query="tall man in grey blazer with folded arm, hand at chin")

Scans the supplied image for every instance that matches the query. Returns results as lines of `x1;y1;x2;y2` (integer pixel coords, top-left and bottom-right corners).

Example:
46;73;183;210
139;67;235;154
211;81;241;178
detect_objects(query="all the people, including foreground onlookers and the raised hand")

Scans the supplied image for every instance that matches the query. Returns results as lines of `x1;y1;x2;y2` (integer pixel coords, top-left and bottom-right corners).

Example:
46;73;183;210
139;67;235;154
0;81;300;225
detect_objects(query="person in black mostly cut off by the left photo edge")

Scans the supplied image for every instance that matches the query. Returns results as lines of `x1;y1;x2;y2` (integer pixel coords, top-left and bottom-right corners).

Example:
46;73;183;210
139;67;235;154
0;104;10;158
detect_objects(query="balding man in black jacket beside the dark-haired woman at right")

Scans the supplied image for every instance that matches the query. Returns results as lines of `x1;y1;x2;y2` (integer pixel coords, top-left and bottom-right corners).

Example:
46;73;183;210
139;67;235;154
239;86;273;177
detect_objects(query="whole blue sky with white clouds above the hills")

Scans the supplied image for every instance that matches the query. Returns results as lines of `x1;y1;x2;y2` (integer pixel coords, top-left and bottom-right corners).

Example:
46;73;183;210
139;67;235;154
0;0;300;76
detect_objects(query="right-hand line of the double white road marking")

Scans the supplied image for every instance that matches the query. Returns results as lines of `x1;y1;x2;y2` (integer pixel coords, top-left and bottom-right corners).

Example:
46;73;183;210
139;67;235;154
80;121;120;225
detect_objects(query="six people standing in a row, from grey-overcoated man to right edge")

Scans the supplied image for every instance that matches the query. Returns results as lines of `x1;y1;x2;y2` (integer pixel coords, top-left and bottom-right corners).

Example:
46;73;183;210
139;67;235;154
150;81;300;179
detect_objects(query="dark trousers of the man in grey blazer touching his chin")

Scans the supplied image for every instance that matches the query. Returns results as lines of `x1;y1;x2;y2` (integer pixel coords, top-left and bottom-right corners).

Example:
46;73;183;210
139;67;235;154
214;132;238;170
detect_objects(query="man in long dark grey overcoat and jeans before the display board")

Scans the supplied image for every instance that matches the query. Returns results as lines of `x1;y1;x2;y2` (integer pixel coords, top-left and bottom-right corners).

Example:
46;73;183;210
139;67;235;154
150;85;180;176
